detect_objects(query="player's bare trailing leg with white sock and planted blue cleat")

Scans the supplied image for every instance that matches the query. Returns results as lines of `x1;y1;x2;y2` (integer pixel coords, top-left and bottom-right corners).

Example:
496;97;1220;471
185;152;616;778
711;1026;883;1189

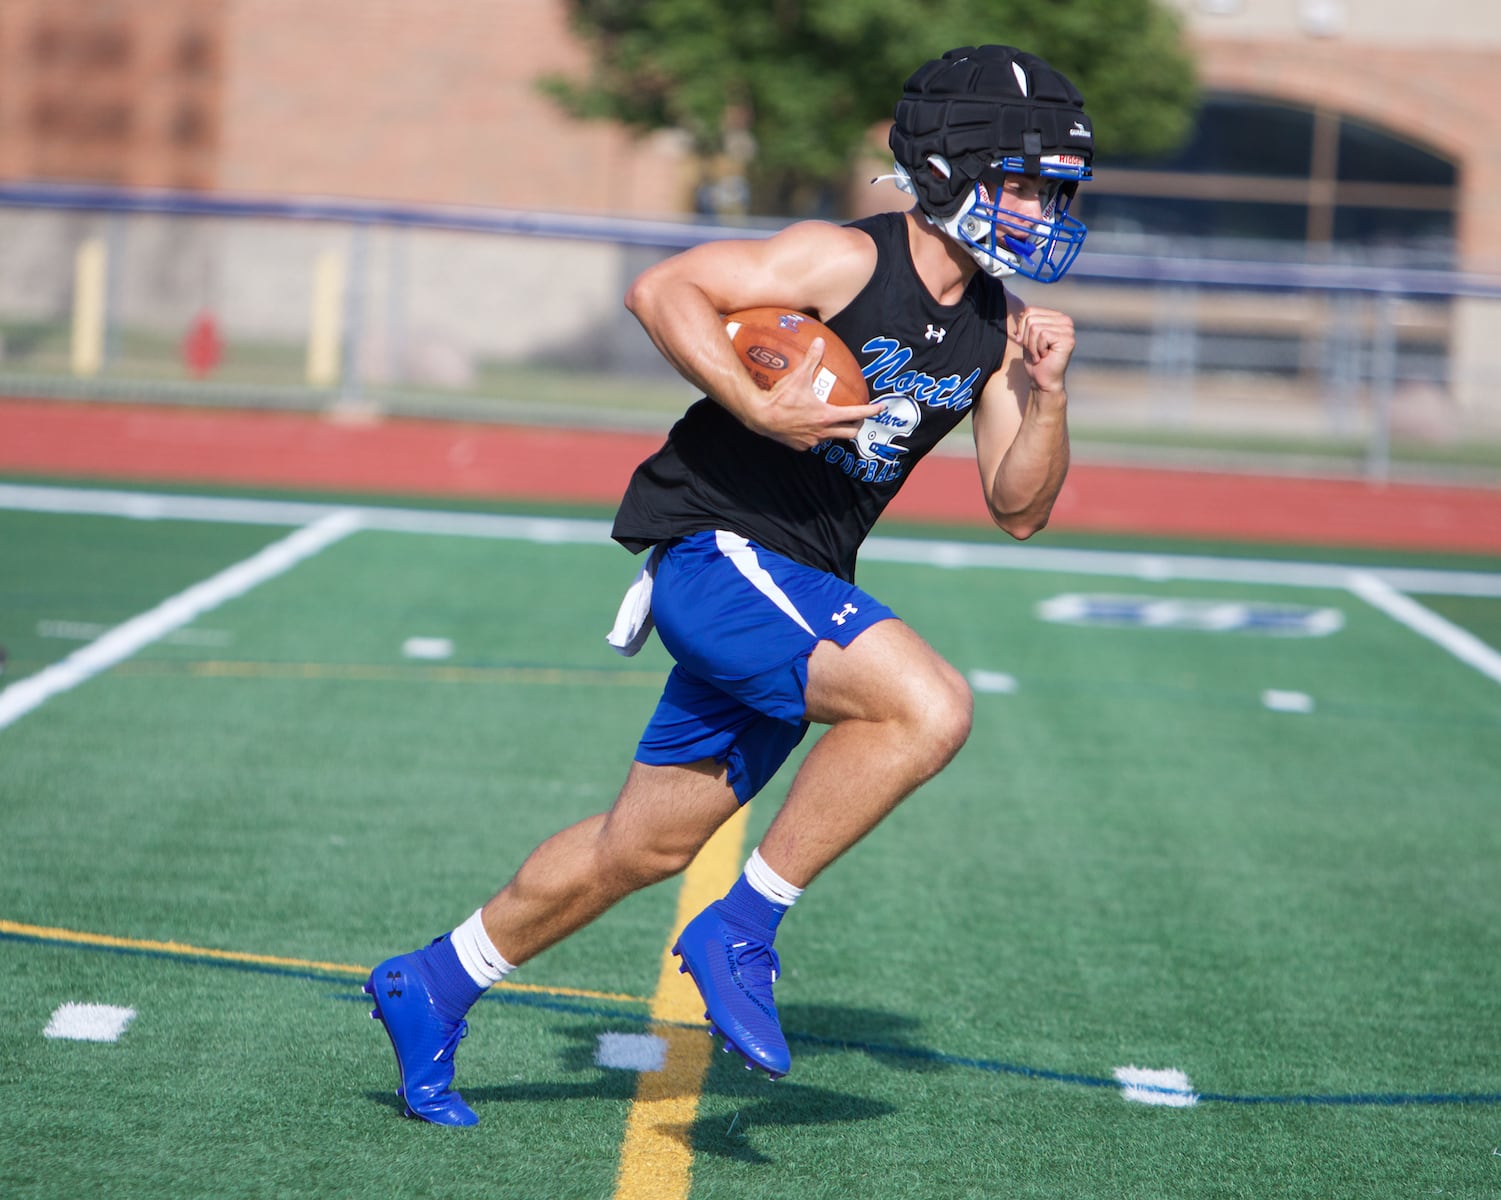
365;761;737;1125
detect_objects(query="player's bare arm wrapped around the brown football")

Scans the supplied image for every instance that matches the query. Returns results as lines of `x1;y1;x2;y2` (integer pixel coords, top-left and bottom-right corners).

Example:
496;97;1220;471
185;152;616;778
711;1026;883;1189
626;221;881;451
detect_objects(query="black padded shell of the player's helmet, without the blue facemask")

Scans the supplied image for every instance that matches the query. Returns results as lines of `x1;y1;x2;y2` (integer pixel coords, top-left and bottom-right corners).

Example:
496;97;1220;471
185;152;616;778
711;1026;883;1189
890;45;1094;216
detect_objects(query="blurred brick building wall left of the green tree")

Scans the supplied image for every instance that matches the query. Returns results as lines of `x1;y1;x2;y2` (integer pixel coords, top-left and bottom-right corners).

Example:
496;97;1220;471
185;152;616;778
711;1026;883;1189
0;0;687;213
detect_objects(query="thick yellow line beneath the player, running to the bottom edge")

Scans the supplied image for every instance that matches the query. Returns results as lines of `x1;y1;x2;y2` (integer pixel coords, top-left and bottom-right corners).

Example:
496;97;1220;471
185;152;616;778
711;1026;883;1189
615;805;751;1200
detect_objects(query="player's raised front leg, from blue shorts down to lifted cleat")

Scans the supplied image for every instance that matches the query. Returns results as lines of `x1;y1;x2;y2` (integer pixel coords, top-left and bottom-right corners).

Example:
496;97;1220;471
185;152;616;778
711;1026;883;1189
653;533;970;1077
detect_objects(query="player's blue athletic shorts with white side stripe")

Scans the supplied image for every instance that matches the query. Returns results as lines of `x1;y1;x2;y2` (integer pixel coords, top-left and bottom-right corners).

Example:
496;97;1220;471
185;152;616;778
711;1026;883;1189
636;530;896;804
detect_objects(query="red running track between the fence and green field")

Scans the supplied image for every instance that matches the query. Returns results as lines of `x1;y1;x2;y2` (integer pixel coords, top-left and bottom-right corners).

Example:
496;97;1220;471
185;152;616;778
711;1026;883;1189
0;399;1501;554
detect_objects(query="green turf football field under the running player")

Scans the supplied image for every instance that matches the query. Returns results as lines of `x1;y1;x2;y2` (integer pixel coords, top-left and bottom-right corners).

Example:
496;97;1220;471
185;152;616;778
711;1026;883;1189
0;488;1501;1200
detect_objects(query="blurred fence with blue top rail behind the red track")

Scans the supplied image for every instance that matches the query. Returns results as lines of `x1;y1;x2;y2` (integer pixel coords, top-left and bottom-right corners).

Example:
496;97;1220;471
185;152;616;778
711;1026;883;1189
0;185;1501;478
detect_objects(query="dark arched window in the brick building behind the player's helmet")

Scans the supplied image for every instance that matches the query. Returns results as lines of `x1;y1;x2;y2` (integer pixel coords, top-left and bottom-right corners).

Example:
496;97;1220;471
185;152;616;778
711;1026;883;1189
1079;93;1457;266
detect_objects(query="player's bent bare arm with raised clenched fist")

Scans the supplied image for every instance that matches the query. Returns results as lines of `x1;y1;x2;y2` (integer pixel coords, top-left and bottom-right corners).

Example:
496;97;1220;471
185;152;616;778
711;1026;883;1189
974;296;1073;539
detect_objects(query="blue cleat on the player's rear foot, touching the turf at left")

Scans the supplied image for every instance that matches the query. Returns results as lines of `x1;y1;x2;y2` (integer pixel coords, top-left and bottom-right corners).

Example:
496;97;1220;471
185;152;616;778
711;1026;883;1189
363;954;479;1125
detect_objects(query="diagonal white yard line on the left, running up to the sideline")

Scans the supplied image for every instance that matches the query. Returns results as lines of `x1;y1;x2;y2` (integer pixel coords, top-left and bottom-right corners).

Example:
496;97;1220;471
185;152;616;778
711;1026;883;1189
0;509;360;730
